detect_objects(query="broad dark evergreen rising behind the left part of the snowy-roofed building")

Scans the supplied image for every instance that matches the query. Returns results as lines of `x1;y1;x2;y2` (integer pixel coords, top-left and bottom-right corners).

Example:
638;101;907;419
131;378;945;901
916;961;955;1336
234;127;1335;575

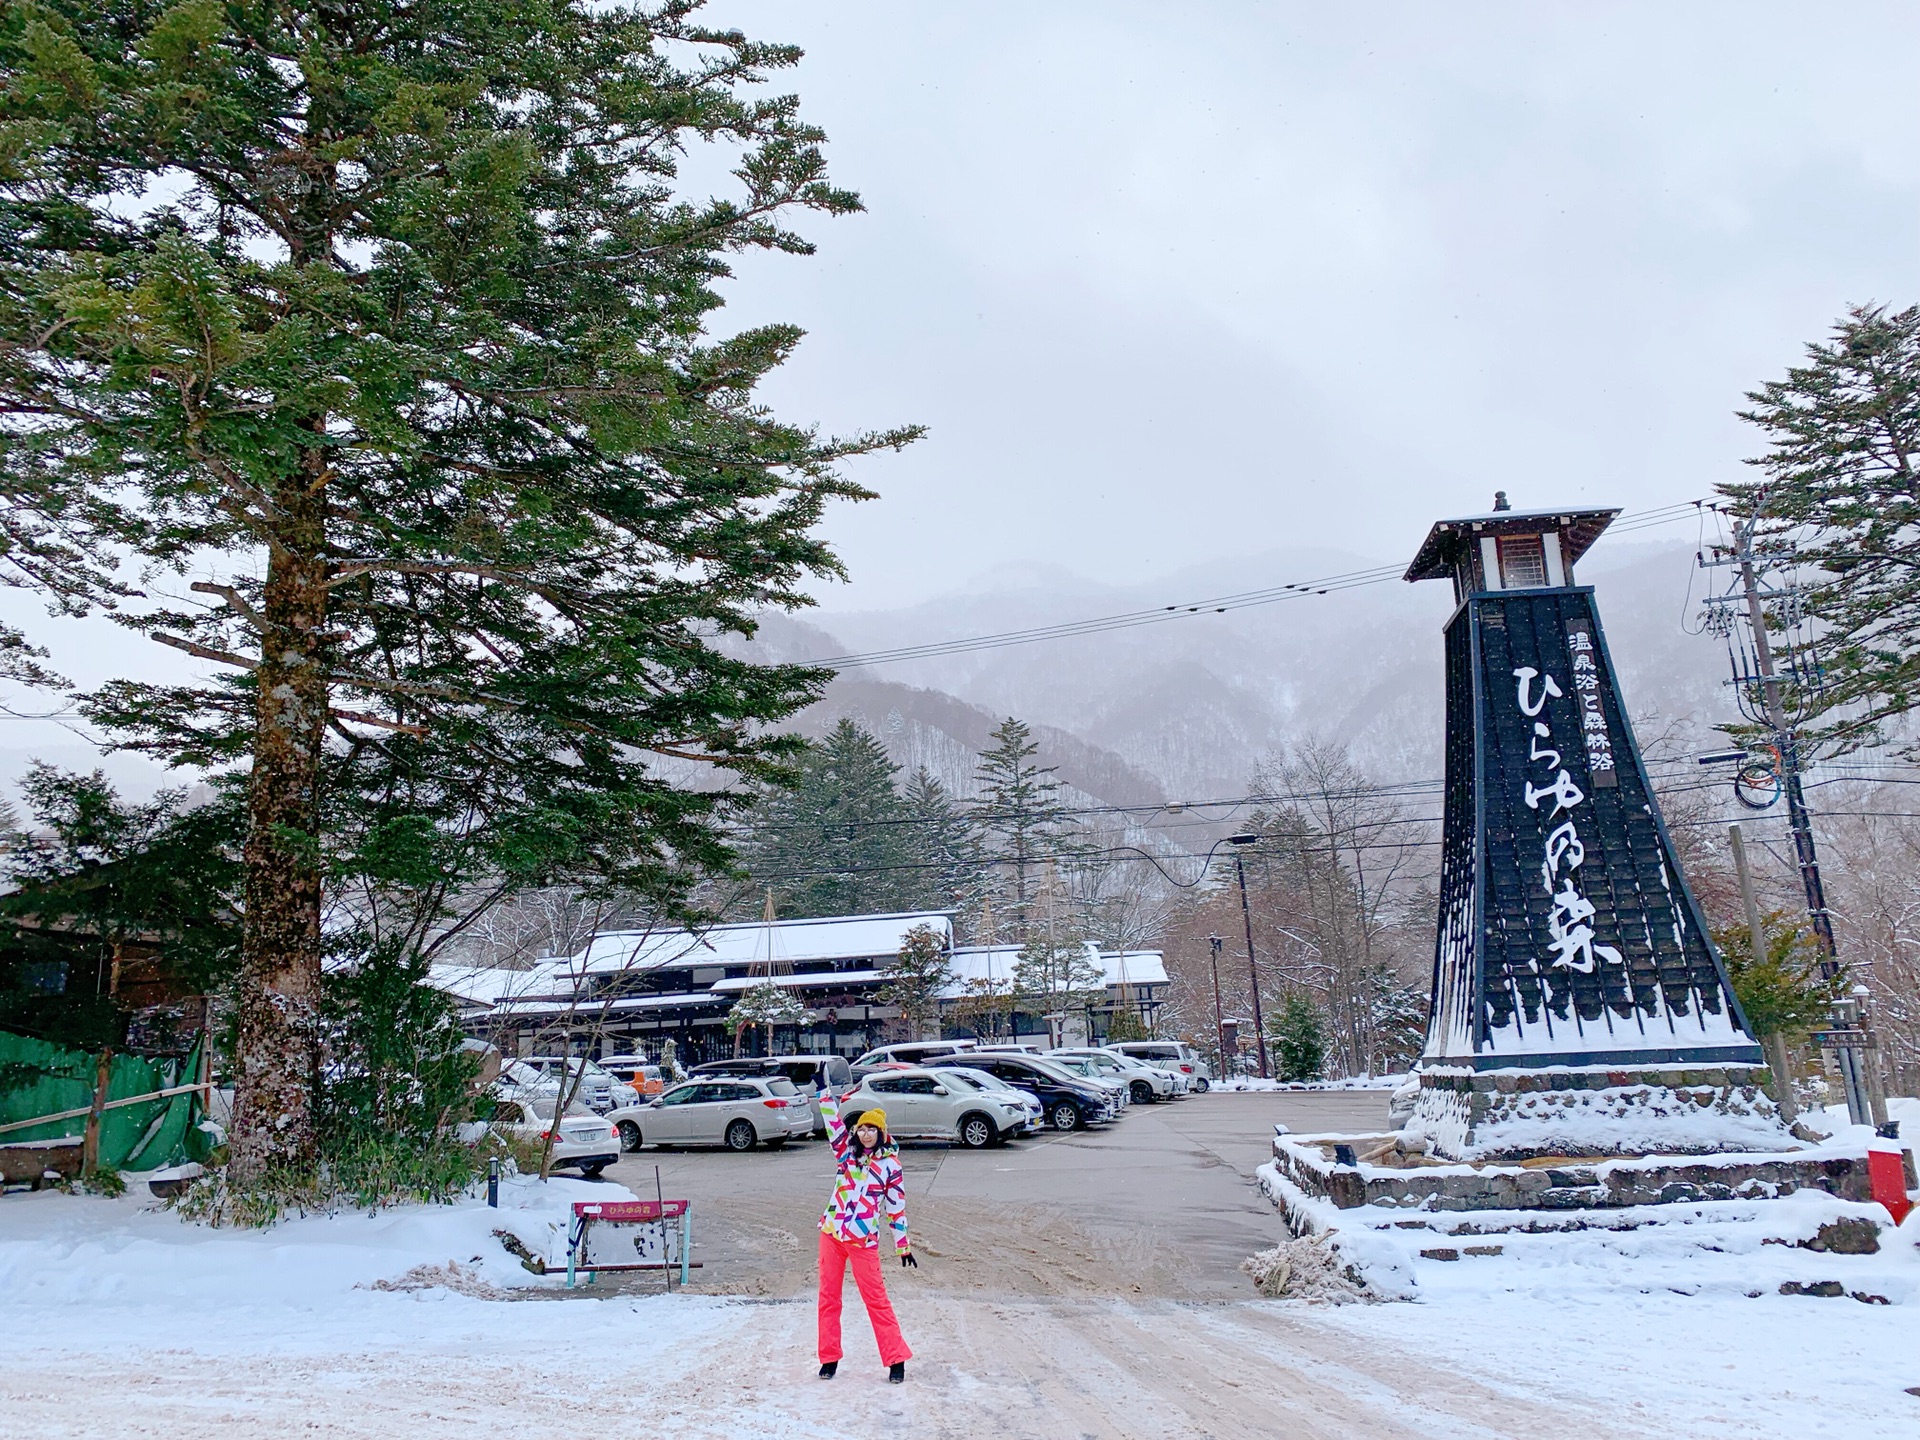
741;720;927;918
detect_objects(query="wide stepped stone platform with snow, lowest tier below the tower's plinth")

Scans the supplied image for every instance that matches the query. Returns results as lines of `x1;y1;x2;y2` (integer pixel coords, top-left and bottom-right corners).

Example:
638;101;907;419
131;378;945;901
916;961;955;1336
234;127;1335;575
1256;1131;1920;1306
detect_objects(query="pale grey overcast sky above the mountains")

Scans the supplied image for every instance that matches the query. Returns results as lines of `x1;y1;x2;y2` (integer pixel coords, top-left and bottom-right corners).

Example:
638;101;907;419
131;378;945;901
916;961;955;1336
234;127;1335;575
708;0;1920;609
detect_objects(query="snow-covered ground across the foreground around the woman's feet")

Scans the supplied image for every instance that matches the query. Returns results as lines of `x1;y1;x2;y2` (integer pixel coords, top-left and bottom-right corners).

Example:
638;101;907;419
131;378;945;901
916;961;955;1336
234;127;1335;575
0;1096;1920;1440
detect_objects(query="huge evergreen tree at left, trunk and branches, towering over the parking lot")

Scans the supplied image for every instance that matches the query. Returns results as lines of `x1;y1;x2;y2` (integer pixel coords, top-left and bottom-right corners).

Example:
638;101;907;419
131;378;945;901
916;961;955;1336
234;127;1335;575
0;0;912;1183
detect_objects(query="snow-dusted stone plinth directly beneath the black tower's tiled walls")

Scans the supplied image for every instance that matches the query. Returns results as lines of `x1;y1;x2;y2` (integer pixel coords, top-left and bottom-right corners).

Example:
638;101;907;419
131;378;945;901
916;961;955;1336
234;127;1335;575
1402;1064;1801;1160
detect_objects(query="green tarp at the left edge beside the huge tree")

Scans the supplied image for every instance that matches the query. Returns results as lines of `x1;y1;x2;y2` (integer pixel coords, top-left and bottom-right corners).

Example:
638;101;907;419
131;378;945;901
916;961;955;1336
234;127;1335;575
0;1031;205;1169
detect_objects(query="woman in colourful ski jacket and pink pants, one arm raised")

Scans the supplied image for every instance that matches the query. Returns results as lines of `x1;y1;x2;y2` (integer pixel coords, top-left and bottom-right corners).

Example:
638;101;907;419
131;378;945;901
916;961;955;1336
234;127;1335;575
820;1079;920;1384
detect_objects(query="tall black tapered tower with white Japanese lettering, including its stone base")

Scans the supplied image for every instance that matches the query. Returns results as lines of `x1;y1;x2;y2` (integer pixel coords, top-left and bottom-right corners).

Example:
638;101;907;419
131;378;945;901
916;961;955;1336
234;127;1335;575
1405;495;1791;1158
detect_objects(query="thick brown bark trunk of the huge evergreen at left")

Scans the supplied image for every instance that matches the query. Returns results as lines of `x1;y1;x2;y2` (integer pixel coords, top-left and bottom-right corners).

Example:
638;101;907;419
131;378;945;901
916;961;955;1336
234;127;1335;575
230;449;328;1185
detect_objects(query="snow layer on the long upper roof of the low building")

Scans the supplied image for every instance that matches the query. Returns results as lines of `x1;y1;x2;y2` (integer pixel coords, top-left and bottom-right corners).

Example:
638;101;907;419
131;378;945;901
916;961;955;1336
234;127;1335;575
572;910;952;973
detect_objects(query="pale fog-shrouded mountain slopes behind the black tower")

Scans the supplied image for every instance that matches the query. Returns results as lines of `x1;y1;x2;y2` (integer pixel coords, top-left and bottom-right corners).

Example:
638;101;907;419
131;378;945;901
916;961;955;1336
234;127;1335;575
753;540;1730;840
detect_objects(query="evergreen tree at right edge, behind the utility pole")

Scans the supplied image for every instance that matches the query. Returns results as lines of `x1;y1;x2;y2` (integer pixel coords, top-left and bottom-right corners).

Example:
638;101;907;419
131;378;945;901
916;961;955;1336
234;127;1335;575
1720;305;1920;747
